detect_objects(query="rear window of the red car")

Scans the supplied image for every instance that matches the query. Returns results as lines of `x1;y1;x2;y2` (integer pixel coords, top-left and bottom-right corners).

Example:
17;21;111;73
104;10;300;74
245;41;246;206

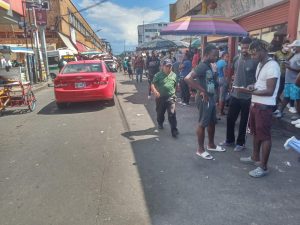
62;63;103;74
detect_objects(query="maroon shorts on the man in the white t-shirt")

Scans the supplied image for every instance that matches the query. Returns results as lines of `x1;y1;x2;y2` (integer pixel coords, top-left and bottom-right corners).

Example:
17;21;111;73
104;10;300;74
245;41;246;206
249;103;274;141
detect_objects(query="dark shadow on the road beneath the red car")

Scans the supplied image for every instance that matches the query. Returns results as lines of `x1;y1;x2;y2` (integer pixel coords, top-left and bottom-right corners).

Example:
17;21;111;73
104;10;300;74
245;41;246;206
38;101;115;115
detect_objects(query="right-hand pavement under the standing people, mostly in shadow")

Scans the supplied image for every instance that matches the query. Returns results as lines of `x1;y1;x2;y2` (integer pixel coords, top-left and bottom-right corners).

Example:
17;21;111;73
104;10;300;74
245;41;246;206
117;74;300;225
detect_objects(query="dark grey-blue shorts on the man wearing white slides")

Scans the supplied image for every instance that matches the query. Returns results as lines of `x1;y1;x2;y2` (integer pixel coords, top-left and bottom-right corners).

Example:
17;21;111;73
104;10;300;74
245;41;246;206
197;96;217;127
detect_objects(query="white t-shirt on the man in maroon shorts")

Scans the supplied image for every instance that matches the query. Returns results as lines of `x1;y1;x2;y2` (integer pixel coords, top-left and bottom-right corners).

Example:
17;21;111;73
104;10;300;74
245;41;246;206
252;60;280;105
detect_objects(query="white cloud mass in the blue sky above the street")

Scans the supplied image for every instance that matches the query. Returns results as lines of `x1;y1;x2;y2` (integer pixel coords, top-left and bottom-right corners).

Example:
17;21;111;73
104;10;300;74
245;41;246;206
80;0;164;51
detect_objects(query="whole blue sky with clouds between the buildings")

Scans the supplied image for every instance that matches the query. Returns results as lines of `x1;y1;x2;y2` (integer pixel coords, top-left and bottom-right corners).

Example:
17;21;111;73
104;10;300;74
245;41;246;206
73;0;176;54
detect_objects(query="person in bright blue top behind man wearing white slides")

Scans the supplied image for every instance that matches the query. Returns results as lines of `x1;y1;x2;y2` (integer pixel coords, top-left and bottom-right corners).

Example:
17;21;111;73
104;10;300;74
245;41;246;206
217;52;230;116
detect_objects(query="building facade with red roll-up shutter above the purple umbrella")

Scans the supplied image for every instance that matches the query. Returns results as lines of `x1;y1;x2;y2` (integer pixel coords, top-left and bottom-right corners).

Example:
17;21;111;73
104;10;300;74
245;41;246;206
170;0;300;42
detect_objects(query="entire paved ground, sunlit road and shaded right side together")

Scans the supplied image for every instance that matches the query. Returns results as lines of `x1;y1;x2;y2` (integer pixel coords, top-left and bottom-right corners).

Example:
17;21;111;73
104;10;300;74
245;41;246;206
0;74;300;225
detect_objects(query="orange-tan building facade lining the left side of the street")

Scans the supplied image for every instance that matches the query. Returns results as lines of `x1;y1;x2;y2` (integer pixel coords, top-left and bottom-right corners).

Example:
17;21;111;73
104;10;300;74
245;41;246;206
0;0;105;54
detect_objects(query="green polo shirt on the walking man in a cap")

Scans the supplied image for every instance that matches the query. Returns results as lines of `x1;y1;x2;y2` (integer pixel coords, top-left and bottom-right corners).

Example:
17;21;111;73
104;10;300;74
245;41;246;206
152;71;177;97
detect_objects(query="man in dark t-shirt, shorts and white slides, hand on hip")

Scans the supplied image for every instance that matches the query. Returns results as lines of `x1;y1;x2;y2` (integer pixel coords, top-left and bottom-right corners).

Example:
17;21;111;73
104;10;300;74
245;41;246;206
185;45;225;160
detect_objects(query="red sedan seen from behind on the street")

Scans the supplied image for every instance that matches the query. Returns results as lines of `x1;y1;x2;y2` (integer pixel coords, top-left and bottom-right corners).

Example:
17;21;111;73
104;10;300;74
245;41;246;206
54;60;116;108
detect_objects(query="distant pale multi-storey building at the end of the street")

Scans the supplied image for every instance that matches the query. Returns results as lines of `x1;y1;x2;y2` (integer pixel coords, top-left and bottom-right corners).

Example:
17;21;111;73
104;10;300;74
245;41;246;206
137;22;168;44
